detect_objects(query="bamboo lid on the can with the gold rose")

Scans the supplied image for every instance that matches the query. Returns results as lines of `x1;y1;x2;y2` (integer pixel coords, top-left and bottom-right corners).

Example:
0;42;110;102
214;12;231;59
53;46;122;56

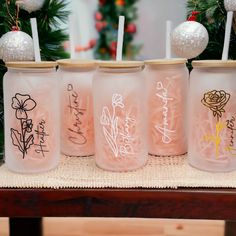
192;60;236;68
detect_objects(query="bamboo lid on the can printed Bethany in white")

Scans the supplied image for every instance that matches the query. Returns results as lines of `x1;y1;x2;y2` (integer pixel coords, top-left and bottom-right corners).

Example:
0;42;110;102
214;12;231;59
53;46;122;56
96;61;144;68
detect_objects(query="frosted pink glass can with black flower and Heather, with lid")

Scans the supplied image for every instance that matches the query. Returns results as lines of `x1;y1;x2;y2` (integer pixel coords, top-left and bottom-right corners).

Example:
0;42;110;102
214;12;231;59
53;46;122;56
3;62;60;173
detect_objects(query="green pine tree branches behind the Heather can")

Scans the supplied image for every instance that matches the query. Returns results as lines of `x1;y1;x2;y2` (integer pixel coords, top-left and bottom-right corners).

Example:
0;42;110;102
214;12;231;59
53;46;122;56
0;0;69;157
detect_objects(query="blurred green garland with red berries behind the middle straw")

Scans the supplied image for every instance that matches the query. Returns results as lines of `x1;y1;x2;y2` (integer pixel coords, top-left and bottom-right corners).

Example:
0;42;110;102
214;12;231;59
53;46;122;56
95;0;140;60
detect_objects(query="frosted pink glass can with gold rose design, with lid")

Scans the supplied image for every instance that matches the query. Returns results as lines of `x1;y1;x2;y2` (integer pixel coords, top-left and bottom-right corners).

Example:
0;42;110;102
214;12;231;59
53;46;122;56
188;60;236;172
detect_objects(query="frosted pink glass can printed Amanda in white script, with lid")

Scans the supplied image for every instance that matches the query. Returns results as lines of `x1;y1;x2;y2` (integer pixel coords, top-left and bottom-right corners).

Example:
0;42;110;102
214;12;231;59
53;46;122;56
145;59;189;156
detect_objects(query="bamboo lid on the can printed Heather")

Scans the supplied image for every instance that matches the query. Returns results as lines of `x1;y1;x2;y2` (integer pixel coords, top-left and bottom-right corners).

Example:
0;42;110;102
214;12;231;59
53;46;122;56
6;61;57;68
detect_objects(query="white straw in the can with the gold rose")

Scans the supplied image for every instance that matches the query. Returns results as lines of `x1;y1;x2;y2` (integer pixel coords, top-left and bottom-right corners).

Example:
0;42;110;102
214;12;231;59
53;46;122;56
222;11;233;60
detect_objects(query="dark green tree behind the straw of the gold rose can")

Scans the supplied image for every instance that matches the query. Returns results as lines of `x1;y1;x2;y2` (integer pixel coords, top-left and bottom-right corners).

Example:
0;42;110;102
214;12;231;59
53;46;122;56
187;0;236;60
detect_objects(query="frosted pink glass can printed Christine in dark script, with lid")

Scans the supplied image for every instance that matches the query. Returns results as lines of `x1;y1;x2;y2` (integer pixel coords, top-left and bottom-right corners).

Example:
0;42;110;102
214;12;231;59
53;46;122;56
58;59;96;156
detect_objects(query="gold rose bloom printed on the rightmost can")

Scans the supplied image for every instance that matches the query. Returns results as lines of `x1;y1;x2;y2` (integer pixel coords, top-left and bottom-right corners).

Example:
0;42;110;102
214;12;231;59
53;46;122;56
201;90;230;121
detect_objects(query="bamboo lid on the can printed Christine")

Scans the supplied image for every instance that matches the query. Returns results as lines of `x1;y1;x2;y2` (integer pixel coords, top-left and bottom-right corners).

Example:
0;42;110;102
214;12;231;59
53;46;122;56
57;59;96;68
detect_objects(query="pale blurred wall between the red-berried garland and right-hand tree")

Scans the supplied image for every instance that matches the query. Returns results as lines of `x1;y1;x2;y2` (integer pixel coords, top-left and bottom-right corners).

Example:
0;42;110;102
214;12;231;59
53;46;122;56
135;0;186;59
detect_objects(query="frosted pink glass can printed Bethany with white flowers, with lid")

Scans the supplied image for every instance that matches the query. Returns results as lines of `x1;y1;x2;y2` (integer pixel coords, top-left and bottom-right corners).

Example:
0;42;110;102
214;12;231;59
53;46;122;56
93;61;148;171
